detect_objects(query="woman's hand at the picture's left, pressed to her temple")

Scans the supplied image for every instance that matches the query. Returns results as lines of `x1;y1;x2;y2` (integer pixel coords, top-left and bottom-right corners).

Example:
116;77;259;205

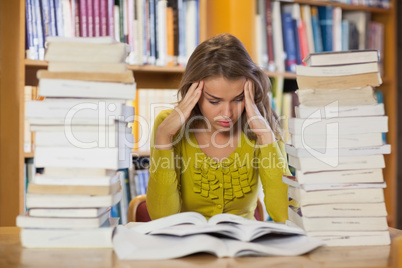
155;81;204;150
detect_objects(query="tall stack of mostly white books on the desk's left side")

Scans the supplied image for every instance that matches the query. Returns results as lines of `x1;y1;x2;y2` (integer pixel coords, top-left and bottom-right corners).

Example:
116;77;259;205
17;38;136;247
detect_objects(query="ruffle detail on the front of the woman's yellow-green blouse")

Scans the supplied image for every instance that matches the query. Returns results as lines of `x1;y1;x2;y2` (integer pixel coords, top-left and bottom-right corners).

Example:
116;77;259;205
193;154;251;201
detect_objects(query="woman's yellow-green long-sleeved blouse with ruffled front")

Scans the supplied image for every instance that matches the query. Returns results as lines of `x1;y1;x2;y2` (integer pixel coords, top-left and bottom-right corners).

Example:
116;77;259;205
147;110;290;222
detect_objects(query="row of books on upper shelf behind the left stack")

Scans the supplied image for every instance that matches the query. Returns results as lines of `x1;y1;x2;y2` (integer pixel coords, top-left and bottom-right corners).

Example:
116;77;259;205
26;0;199;66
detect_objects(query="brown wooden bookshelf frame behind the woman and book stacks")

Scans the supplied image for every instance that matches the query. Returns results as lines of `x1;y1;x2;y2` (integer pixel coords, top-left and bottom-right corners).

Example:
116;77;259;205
0;0;397;227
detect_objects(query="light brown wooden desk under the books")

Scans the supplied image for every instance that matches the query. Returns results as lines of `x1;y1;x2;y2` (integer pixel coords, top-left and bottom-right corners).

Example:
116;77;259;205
0;227;402;268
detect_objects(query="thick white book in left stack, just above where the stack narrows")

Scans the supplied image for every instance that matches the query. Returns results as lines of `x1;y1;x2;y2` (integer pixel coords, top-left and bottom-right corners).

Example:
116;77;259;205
34;147;132;169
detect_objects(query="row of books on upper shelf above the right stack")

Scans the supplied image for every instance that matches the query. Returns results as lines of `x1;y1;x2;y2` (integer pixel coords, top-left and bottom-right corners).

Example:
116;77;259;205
255;0;384;72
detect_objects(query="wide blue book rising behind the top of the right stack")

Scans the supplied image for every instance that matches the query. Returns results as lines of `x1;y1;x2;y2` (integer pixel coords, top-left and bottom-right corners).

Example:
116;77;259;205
318;6;334;51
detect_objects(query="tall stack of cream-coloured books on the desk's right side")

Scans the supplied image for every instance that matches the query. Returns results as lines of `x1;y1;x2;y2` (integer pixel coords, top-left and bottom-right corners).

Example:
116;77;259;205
283;50;391;246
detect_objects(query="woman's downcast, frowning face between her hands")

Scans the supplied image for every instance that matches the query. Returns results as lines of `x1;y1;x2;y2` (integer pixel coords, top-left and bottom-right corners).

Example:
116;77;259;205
198;76;246;131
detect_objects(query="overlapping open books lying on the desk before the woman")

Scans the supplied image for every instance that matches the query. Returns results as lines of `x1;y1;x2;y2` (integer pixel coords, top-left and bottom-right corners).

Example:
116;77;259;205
113;212;324;259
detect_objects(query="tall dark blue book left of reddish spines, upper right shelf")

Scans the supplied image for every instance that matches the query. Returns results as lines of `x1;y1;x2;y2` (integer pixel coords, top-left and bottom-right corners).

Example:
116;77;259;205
282;6;297;72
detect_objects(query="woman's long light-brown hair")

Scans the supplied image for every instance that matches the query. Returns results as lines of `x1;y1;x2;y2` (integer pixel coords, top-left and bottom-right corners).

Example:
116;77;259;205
178;34;282;140
